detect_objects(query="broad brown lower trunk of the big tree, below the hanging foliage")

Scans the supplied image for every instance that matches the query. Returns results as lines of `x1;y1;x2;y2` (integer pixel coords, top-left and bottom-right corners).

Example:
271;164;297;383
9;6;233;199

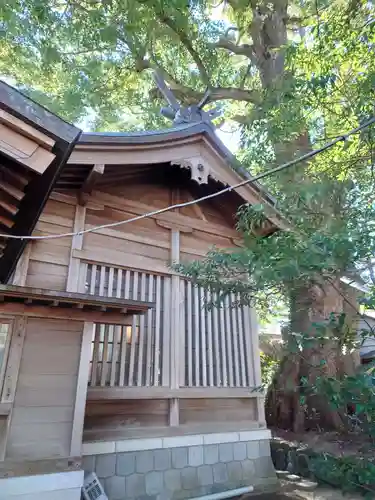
266;281;352;432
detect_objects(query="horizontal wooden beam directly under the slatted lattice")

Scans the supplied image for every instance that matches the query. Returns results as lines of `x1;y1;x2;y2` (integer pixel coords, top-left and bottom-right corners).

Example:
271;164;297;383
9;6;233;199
87;386;261;401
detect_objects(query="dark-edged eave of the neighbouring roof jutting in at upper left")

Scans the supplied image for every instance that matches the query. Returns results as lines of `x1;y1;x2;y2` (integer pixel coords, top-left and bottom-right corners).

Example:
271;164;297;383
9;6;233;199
0;81;81;283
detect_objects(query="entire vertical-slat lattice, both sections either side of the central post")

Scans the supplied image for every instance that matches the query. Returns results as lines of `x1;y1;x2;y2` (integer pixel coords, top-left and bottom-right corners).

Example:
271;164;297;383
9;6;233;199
83;263;254;388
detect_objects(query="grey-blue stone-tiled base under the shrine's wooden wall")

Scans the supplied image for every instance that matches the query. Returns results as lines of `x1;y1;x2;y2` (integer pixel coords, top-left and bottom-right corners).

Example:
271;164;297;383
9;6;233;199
83;433;277;500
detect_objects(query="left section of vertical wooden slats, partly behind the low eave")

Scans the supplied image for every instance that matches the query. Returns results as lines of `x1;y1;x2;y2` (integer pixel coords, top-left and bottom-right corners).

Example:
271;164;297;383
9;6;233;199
86;264;170;387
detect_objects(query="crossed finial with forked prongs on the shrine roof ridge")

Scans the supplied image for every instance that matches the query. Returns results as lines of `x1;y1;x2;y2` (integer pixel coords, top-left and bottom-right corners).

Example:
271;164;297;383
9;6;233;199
154;70;221;127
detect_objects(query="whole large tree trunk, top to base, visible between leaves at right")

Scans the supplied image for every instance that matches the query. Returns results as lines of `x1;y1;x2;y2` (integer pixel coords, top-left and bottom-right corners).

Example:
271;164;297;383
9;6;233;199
249;0;352;432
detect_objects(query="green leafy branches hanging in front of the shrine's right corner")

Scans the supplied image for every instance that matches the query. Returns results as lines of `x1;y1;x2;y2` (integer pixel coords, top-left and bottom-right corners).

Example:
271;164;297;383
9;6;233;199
179;186;375;309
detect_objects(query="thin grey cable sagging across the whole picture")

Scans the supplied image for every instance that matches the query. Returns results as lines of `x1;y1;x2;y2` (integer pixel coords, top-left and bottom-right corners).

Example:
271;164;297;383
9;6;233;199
0;116;375;240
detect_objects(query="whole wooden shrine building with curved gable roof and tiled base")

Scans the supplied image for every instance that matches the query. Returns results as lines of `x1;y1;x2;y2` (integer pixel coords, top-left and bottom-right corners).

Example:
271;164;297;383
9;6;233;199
0;83;283;500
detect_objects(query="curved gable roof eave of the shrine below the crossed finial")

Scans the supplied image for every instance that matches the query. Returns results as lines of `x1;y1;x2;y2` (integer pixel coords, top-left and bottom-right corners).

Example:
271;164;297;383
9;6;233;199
62;123;290;233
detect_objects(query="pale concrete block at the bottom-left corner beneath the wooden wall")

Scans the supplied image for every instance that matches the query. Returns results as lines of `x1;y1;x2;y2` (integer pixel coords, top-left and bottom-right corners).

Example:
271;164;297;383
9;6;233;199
0;471;83;500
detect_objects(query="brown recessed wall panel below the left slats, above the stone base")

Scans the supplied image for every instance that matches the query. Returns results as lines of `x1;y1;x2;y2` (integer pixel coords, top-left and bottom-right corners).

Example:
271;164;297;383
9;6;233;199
85;399;169;435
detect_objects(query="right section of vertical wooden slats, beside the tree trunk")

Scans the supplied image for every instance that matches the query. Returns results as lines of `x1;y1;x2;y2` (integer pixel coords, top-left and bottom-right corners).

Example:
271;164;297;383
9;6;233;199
181;281;253;387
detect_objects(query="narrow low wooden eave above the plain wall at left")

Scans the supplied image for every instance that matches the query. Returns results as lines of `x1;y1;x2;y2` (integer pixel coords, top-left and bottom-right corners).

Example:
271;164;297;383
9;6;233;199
0;285;154;324
